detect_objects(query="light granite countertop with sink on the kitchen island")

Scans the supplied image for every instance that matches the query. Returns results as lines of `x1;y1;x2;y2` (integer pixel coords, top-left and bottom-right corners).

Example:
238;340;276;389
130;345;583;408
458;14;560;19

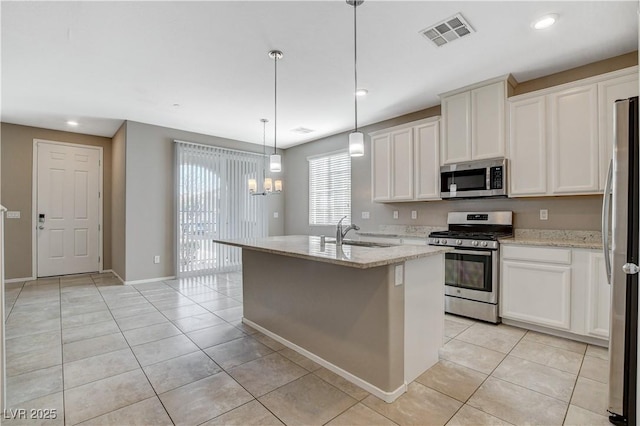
213;235;452;269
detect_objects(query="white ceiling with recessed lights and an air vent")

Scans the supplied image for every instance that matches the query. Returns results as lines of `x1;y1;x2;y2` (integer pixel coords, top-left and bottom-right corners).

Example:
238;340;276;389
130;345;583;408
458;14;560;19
1;0;638;147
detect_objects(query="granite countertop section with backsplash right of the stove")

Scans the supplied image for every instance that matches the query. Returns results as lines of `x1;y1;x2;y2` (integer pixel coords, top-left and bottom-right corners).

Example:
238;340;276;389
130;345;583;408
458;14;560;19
500;229;602;250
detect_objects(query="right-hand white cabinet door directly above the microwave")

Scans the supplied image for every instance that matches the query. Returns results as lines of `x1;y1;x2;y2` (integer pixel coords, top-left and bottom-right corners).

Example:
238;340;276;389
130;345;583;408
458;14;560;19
471;81;506;160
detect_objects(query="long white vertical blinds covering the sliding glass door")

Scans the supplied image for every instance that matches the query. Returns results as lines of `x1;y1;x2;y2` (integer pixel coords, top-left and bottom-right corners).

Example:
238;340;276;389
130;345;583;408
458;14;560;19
175;141;267;276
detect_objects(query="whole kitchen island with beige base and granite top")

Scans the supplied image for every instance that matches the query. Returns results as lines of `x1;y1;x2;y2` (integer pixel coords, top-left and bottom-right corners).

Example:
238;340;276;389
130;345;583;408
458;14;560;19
215;236;450;402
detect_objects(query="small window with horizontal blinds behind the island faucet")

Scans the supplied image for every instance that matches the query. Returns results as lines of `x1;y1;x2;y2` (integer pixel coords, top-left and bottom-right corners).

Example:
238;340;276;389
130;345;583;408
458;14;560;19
308;151;351;225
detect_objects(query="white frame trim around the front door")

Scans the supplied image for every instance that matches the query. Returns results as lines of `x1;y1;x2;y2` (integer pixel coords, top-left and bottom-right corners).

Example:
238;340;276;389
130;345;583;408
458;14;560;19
31;138;104;279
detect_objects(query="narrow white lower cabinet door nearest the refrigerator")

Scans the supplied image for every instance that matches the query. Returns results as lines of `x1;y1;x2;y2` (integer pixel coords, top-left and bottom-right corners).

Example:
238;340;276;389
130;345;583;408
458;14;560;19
586;253;611;339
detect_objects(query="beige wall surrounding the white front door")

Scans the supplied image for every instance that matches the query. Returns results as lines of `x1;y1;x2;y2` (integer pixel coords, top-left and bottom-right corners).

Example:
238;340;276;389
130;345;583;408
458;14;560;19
0;123;112;279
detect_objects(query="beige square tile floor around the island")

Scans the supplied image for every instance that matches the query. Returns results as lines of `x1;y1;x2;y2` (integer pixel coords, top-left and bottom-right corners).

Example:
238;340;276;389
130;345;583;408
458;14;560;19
2;273;609;425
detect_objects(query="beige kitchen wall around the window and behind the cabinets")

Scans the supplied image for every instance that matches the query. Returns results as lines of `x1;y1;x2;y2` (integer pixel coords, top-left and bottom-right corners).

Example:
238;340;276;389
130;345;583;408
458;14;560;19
284;52;638;235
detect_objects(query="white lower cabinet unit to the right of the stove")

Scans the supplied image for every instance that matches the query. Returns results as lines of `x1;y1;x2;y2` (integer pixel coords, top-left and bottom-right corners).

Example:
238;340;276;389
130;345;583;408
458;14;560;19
500;245;610;339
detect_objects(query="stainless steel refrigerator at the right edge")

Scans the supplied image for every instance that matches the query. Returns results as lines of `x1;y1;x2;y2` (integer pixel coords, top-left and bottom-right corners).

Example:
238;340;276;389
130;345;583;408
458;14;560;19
602;97;640;425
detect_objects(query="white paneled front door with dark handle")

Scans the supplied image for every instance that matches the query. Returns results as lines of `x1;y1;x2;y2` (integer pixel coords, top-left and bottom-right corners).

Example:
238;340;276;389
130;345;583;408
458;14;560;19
35;141;101;277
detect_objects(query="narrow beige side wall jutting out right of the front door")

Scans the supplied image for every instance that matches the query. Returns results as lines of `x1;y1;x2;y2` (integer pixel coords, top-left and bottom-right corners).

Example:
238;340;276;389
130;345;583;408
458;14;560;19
111;122;127;277
